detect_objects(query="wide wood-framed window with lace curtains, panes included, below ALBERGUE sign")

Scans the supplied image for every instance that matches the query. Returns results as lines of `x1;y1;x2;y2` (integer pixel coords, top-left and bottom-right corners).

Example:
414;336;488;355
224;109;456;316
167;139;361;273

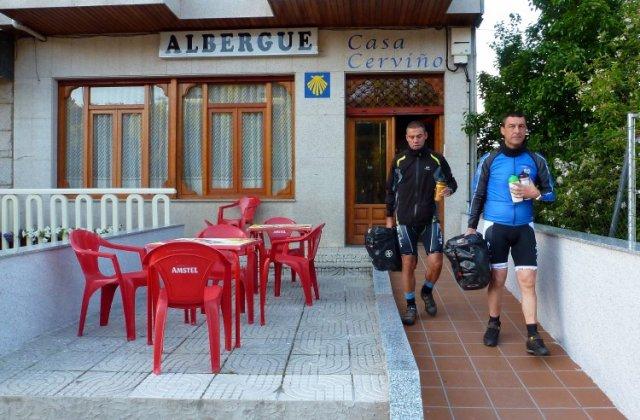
58;79;293;198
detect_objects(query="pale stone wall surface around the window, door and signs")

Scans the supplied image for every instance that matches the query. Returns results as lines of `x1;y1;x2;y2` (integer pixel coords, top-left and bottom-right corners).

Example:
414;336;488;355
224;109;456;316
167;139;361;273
8;29;468;246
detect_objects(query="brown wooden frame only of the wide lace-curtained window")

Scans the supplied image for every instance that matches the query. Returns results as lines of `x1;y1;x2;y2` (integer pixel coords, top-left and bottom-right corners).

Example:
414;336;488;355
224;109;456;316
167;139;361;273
57;76;295;200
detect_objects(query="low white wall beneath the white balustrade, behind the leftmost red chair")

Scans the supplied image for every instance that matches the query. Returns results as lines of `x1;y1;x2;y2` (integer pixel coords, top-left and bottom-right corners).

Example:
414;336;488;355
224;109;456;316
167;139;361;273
0;225;184;355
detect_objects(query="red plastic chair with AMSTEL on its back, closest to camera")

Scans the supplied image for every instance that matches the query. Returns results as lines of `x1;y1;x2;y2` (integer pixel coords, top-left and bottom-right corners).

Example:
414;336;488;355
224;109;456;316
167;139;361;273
145;243;231;375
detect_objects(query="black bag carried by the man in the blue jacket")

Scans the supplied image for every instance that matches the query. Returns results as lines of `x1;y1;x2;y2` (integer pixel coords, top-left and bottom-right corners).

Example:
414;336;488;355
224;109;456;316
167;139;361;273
444;232;491;290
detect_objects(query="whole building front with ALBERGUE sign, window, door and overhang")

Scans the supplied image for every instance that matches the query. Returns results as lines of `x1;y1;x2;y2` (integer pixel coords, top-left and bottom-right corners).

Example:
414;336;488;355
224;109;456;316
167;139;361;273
0;0;482;246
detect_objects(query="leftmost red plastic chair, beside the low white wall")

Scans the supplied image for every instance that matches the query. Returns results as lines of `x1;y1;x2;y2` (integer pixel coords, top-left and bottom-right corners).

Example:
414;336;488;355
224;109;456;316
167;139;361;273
69;229;147;340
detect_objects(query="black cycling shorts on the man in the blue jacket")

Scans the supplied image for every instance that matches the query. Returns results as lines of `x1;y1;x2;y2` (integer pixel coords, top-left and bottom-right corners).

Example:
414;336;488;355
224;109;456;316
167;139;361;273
483;220;538;270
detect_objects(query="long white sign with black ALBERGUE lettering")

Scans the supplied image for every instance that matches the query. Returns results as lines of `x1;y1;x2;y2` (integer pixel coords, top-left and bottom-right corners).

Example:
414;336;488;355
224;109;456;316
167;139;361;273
159;28;318;58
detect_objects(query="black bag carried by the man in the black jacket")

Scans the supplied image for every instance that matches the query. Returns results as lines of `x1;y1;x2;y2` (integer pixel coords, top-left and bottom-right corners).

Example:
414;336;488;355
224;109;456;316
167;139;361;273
364;226;402;271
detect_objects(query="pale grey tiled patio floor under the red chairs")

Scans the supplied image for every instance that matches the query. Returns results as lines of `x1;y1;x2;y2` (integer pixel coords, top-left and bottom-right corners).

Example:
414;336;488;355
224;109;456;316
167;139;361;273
0;270;388;418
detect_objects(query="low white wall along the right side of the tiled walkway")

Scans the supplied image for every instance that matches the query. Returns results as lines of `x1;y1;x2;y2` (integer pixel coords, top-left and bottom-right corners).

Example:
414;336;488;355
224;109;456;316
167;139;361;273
507;225;640;418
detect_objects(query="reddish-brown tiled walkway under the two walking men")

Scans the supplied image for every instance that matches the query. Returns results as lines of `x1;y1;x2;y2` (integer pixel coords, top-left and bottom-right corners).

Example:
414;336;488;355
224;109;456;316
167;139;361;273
391;254;624;420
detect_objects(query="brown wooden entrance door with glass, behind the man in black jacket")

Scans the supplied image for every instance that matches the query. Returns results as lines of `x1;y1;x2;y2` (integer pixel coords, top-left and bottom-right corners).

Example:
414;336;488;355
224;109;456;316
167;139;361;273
346;115;444;245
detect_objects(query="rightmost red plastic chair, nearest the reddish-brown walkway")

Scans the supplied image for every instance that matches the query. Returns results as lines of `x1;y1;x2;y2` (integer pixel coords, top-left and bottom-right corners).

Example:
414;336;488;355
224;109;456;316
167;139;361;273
260;223;325;324
